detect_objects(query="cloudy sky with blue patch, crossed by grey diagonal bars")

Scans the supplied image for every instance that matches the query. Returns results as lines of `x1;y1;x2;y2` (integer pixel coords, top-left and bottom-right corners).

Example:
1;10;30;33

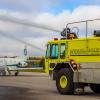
0;0;100;56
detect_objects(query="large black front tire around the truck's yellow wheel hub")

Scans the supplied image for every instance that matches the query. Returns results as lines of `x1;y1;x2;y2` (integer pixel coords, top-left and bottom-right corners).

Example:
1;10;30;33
56;68;74;95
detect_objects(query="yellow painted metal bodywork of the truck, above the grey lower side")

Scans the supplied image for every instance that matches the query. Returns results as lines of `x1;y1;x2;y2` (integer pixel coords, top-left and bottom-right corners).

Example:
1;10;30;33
45;37;100;72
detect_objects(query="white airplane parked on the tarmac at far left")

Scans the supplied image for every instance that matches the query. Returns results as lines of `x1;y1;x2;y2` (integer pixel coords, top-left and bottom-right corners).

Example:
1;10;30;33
0;56;28;76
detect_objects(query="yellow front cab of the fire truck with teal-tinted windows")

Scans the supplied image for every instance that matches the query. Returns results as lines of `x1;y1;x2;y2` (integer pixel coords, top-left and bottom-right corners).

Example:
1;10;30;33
45;39;67;75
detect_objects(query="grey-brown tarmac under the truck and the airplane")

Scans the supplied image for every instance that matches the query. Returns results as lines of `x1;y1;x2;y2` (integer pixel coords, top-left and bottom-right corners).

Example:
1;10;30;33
0;72;100;100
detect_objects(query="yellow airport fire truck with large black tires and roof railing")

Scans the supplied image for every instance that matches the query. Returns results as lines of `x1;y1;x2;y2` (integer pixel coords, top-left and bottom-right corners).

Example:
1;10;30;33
45;19;100;94
